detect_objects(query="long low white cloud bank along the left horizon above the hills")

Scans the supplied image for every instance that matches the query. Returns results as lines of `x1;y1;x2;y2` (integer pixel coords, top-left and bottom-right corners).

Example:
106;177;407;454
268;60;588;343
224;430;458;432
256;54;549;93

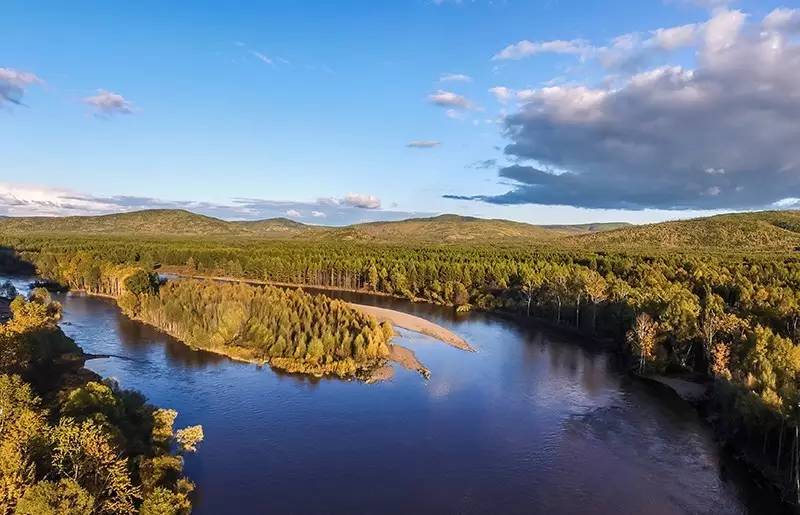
0;182;412;225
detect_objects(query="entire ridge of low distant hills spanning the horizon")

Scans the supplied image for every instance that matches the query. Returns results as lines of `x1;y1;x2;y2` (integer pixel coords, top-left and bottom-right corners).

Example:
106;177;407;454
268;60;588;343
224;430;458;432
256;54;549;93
0;209;800;252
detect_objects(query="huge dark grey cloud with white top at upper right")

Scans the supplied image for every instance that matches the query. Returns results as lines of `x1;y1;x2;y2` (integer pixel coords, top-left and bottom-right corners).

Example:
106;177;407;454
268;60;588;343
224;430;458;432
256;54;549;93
451;9;800;209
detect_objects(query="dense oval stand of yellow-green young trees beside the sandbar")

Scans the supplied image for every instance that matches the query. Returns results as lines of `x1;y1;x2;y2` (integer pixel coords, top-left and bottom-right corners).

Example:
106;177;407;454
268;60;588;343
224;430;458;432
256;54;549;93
137;280;391;377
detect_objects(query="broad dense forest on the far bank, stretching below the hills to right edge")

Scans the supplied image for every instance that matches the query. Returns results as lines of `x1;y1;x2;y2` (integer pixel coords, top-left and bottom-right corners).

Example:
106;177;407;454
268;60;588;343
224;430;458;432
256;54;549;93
4;232;800;506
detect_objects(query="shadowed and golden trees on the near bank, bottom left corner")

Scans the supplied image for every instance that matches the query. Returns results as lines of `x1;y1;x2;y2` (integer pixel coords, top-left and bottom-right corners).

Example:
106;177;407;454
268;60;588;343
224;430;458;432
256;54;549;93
0;285;203;515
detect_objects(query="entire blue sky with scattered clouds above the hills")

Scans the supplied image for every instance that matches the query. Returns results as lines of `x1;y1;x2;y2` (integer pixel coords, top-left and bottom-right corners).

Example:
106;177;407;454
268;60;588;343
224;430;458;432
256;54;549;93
0;0;800;225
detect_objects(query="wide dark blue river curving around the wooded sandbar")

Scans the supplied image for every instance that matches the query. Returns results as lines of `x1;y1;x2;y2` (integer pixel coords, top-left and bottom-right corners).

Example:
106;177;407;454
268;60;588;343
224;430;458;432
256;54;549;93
0;278;779;515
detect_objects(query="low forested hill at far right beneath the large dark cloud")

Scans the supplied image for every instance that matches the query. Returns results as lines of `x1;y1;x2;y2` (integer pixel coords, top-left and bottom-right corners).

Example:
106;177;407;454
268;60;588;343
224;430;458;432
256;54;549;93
576;211;800;252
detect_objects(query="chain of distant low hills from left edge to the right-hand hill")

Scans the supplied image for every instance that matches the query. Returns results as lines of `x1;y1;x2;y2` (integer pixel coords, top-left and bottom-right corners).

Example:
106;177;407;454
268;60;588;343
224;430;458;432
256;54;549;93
0;209;613;243
